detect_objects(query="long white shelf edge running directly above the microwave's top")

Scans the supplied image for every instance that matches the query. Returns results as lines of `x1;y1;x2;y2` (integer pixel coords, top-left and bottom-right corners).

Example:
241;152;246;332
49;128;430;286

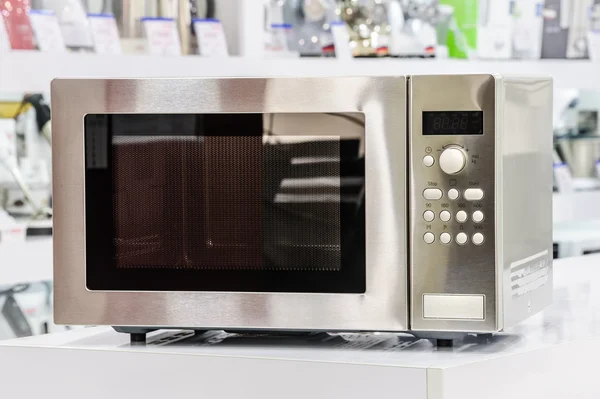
0;51;600;92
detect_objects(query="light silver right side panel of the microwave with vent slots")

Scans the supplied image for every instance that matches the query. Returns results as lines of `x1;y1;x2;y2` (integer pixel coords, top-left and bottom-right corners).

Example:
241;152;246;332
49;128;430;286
498;76;553;328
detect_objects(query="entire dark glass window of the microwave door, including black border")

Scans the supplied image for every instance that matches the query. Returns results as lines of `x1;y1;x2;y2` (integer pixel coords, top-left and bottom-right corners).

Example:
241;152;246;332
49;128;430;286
85;113;366;293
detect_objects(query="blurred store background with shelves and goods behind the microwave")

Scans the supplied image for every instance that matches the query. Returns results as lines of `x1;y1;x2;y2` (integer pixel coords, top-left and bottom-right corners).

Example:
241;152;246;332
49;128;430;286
0;0;600;339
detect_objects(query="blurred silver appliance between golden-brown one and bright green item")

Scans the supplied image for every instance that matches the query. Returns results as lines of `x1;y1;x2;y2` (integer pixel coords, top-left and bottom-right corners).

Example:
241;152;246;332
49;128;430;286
384;0;439;57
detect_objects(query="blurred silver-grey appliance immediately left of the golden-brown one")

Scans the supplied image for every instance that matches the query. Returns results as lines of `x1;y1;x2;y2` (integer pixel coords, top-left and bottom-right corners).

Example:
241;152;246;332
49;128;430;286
284;0;337;57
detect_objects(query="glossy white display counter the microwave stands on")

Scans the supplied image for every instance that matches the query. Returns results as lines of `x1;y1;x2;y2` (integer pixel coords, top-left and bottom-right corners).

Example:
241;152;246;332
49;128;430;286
0;256;600;399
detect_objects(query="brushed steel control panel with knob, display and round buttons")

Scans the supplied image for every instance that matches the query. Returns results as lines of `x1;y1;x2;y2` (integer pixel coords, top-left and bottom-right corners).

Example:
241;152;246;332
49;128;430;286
409;75;497;332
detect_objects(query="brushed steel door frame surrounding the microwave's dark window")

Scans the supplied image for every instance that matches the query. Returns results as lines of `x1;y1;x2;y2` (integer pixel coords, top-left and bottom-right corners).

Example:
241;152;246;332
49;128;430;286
52;76;408;331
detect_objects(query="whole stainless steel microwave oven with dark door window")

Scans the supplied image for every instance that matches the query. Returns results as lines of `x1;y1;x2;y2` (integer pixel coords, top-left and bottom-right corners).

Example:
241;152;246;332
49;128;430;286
51;74;552;346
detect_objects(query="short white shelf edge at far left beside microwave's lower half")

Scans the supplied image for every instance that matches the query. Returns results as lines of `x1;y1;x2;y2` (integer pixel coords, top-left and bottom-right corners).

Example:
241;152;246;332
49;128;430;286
0;237;52;286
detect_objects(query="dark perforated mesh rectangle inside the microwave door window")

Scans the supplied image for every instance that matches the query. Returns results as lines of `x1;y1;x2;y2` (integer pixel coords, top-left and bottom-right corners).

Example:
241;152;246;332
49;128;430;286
112;136;341;270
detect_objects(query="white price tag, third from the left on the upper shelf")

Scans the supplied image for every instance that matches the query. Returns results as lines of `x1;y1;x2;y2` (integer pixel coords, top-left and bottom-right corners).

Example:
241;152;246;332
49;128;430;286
142;17;181;55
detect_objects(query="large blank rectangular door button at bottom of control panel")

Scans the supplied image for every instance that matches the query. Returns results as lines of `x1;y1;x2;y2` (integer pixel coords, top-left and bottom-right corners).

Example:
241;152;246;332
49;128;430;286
423;294;485;320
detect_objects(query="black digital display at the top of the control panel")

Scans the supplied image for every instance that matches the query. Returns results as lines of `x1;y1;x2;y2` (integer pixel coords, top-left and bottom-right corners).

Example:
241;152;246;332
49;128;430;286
423;111;483;136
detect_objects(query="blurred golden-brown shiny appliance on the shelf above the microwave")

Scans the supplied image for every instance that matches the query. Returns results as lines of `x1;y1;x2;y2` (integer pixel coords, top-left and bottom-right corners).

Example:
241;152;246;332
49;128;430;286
340;0;392;57
